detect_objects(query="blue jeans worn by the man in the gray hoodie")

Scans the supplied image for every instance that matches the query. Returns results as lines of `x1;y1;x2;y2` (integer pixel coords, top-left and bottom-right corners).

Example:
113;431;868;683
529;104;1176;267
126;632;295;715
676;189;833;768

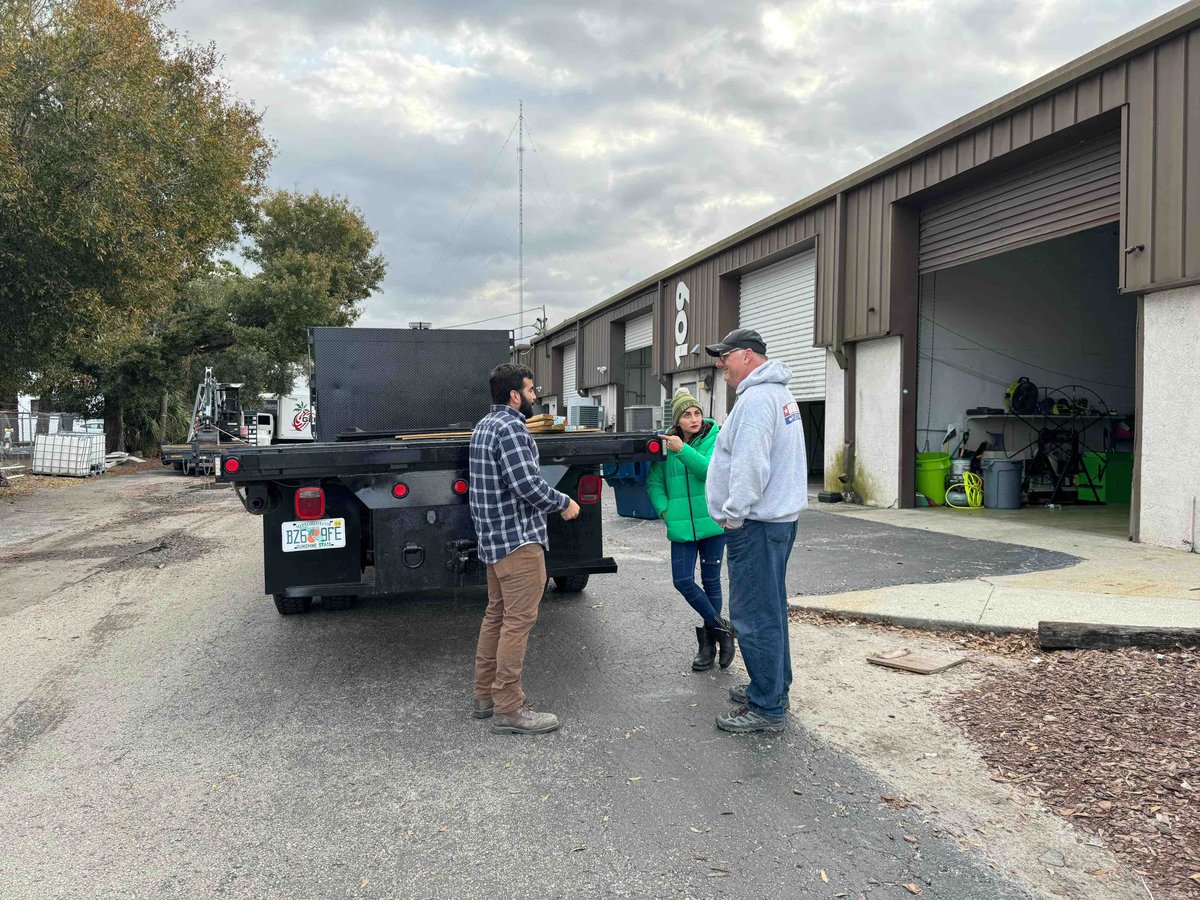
728;518;796;719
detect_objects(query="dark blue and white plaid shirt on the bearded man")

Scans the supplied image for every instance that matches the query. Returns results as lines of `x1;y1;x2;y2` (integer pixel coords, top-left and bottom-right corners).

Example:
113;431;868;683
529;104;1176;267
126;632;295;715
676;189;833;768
468;406;571;565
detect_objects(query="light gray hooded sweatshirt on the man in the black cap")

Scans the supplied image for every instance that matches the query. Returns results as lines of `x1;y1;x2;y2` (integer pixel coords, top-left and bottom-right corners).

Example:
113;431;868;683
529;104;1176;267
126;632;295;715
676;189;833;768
706;360;809;527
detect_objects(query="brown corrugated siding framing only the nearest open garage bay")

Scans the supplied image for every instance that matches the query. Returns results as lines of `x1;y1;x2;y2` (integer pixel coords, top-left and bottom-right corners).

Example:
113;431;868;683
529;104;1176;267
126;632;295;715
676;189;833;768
844;29;1200;341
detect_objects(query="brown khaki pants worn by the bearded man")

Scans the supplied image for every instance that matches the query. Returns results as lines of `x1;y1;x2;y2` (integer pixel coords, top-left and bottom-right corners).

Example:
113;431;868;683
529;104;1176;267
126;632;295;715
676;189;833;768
475;544;546;715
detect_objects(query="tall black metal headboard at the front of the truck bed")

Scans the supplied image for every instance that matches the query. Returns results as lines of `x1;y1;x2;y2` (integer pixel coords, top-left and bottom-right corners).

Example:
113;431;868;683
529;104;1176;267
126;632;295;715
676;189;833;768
308;328;511;440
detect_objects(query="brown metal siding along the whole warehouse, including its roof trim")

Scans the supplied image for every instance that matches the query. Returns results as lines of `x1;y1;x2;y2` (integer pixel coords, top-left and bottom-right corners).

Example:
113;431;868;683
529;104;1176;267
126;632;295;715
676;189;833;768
535;13;1200;360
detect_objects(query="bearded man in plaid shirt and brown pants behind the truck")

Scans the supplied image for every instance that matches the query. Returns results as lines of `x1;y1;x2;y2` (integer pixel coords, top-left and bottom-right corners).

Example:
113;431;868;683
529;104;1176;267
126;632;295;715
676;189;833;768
468;364;580;734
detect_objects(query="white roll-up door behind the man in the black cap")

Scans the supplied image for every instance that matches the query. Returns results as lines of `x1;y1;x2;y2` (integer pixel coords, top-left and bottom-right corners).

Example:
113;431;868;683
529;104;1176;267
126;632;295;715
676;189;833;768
738;250;826;403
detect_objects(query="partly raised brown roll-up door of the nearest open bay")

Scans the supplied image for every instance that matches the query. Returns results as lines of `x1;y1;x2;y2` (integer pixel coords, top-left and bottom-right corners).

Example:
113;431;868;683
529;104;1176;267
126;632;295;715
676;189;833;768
920;133;1121;272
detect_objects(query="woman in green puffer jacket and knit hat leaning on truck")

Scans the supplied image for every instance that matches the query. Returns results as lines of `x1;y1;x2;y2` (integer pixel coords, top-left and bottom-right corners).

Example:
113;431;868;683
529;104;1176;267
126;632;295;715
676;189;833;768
646;391;734;672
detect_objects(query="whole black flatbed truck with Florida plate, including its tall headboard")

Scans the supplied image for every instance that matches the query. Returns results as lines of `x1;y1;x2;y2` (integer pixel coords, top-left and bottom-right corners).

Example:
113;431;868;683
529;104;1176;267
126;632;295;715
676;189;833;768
217;329;662;616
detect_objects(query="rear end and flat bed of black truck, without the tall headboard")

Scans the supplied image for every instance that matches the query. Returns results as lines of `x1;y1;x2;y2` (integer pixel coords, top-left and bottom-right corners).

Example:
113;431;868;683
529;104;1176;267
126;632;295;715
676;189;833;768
217;432;662;614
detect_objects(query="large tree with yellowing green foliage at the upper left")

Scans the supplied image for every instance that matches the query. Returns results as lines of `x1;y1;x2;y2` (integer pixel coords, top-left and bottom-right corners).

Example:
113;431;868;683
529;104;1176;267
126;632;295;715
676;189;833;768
0;0;271;398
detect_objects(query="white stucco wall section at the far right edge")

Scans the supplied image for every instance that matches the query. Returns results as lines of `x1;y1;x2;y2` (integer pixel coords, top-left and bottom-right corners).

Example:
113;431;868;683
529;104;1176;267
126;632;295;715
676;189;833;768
1139;287;1200;552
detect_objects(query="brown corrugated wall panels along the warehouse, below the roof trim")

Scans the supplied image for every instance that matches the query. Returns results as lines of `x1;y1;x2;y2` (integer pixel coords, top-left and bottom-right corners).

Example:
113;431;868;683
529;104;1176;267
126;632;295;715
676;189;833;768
535;16;1200;362
